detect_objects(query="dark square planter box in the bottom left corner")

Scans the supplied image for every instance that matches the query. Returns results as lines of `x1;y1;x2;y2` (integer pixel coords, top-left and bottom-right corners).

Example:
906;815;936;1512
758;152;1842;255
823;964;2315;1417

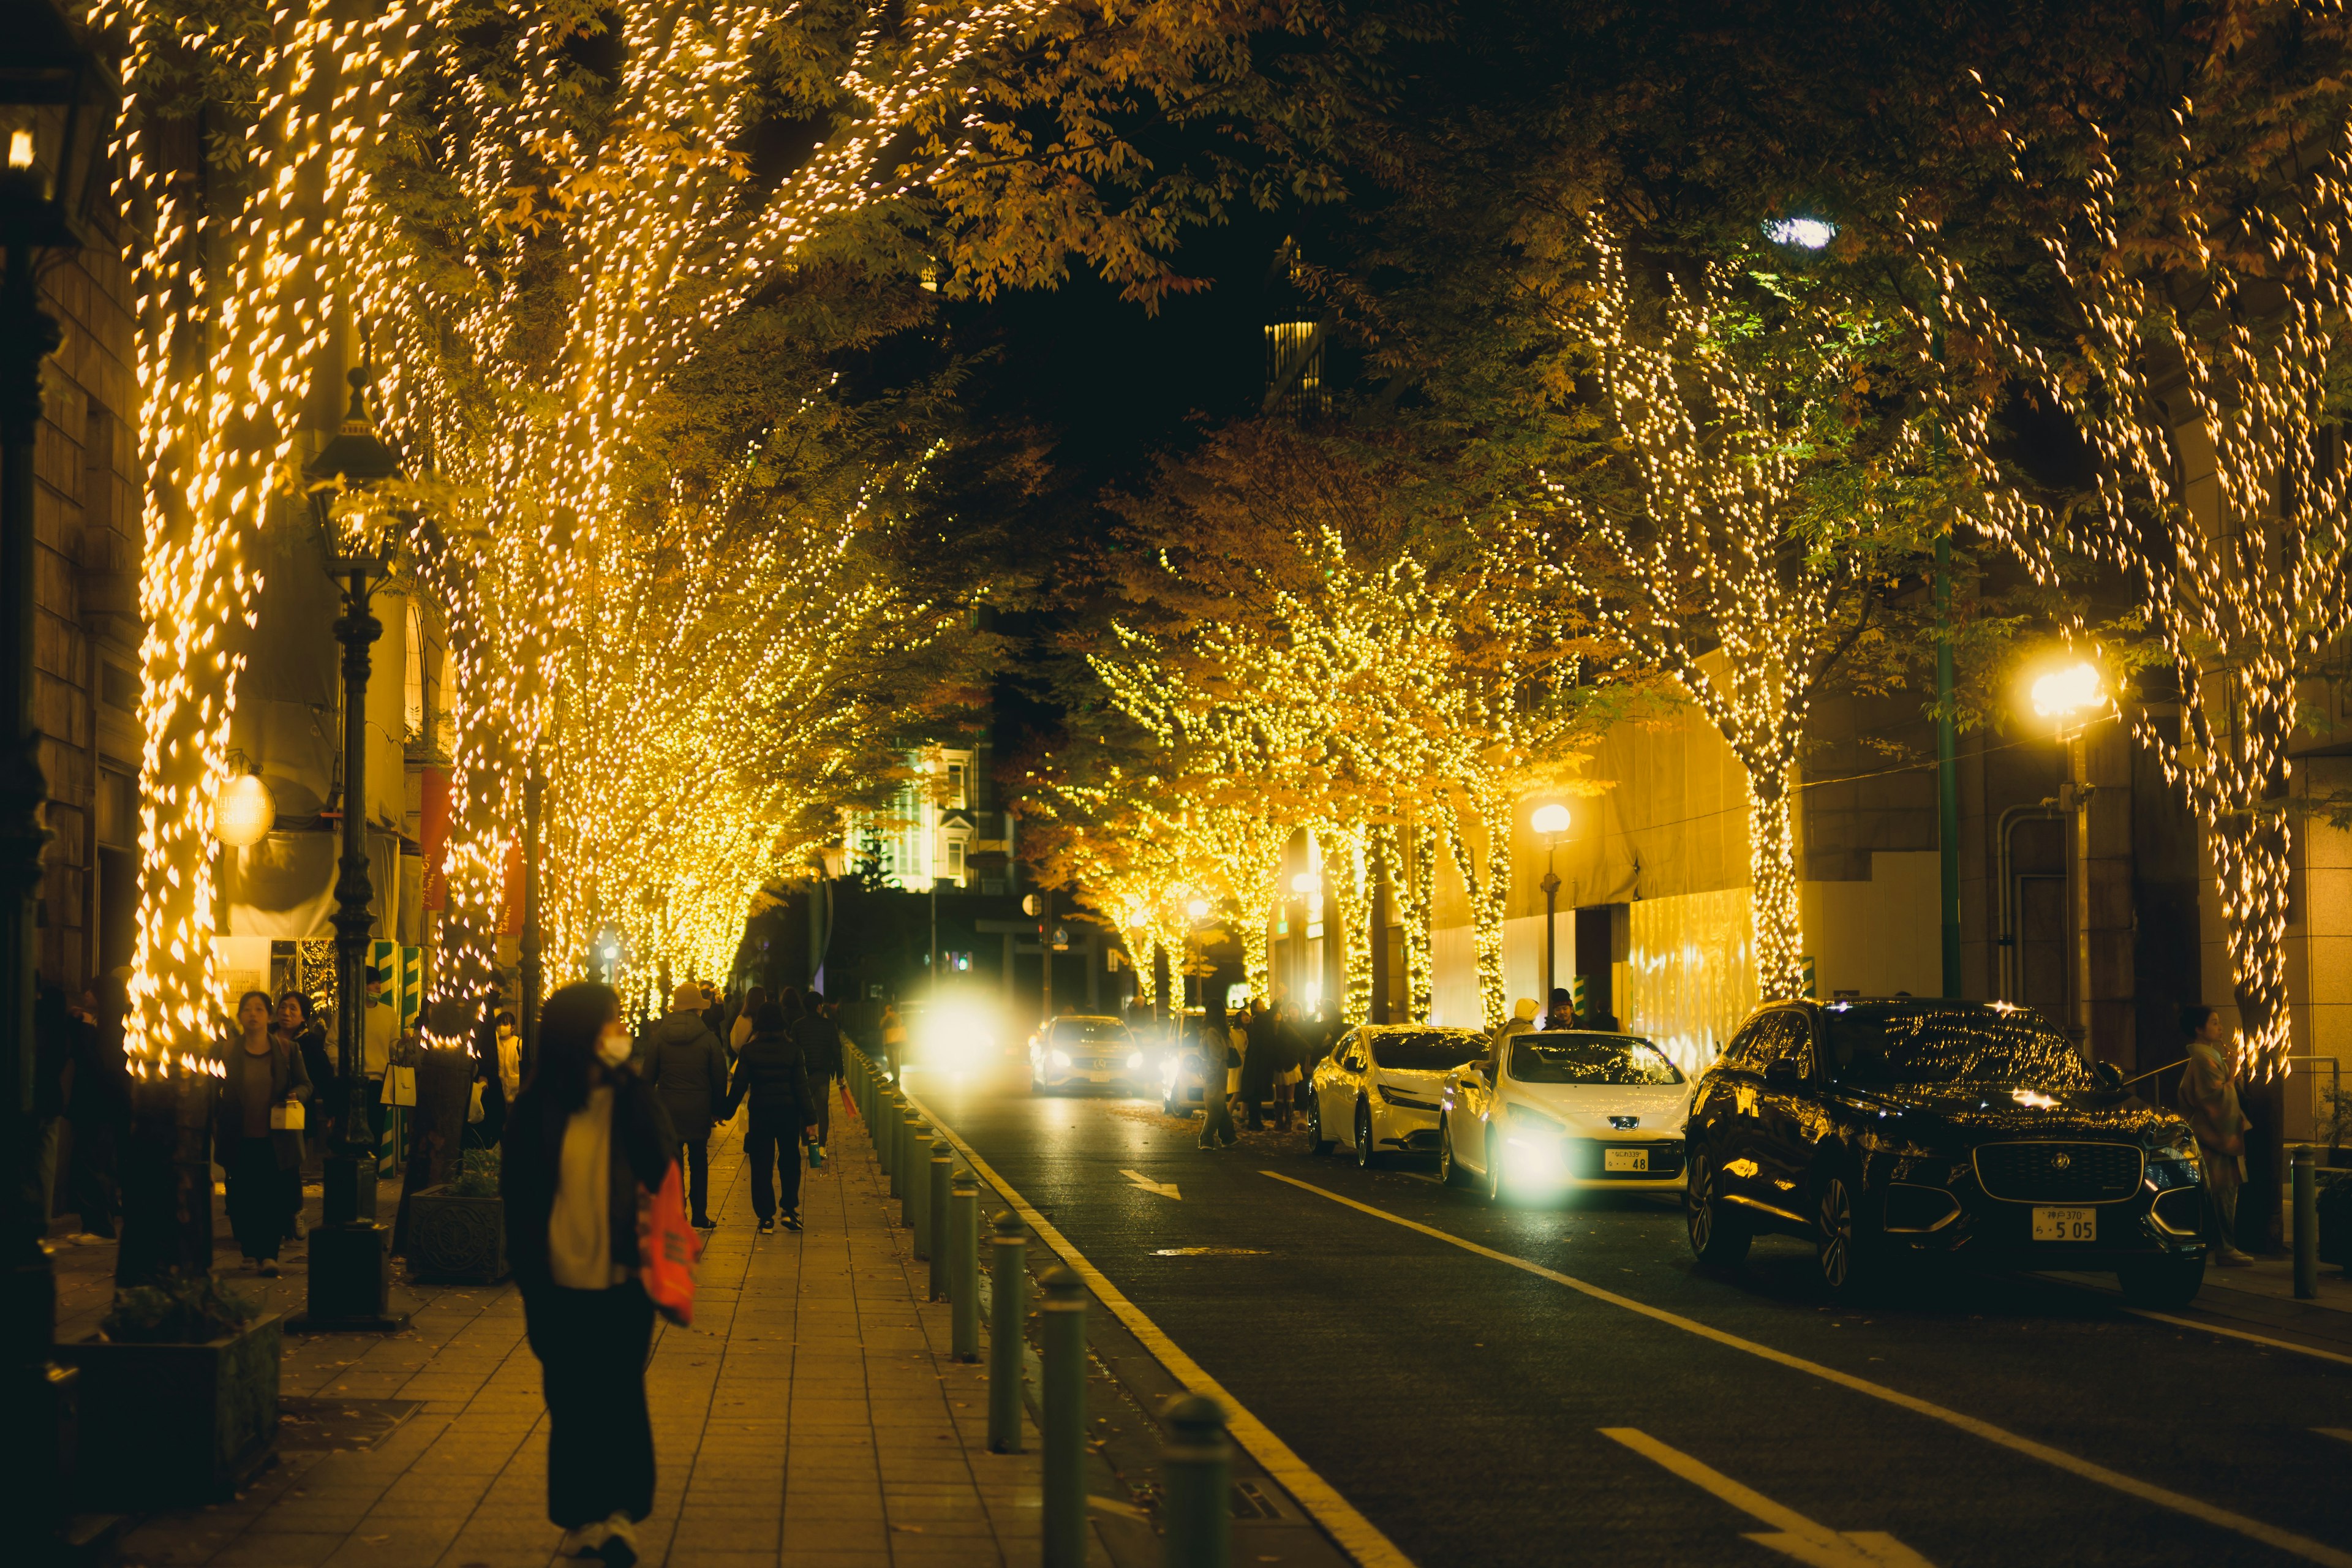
56;1312;280;1512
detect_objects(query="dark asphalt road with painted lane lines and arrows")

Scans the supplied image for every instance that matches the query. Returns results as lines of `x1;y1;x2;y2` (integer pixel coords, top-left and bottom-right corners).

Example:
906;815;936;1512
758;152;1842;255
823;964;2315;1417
910;1074;2352;1568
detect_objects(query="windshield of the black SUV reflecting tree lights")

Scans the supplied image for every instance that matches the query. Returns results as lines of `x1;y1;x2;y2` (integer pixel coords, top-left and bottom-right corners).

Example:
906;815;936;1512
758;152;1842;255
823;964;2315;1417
1823;1001;2098;1088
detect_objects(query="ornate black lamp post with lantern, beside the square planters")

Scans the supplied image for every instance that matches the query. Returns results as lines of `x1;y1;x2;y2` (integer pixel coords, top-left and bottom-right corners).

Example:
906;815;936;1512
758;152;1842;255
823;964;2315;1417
299;369;409;1333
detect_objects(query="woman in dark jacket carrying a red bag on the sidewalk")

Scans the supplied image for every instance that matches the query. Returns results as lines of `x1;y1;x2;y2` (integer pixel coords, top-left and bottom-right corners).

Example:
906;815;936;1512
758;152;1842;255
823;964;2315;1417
499;980;677;1568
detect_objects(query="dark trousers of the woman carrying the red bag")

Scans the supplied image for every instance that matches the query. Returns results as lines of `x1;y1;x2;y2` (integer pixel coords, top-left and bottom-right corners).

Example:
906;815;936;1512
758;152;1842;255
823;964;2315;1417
522;1281;654;1531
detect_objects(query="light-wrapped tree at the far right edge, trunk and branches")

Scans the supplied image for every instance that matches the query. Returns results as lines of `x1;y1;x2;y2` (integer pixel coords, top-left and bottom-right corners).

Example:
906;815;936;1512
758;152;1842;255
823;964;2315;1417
1893;21;2352;1081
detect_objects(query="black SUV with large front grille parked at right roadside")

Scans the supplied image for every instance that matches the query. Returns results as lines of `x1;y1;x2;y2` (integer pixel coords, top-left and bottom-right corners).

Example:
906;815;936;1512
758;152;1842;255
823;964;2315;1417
1684;997;2206;1307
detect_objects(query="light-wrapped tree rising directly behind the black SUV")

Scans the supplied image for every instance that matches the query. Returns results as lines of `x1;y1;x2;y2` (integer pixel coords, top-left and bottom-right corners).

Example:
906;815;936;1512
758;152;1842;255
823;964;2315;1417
1552;224;1924;1001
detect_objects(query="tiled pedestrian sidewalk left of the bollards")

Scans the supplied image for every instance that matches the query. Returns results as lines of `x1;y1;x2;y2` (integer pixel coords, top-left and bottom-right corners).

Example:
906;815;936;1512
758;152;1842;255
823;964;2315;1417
56;1090;1039;1568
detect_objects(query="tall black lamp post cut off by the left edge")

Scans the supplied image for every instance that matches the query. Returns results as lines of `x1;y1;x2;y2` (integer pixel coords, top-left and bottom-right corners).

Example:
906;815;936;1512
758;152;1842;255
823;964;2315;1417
0;0;120;1554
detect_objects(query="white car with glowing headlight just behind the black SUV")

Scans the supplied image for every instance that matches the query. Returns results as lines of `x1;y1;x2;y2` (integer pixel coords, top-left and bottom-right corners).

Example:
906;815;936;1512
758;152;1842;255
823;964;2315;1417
1437;1030;1694;1201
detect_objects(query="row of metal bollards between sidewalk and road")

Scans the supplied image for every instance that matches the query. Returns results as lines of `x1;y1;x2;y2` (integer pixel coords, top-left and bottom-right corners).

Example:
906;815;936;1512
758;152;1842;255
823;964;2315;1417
849;1053;1251;1568
